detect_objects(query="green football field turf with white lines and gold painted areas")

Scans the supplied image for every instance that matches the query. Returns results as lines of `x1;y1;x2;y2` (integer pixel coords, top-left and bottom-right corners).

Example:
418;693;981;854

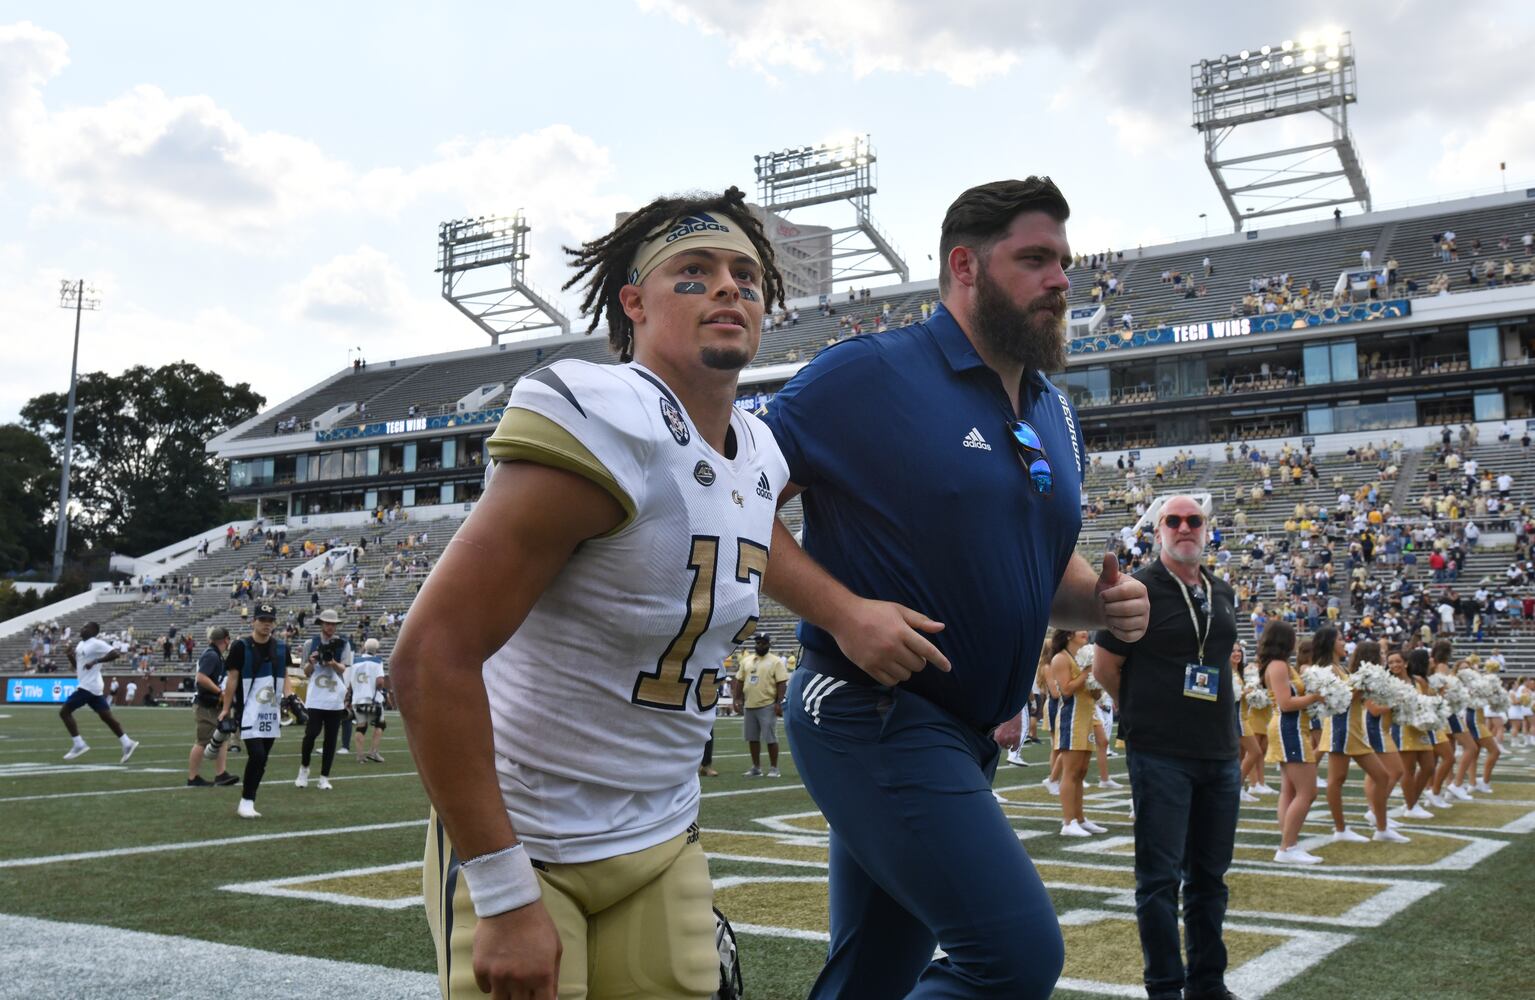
0;705;1535;1000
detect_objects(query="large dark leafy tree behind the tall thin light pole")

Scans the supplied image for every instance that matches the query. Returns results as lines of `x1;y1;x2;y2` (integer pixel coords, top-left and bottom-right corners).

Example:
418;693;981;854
21;361;266;553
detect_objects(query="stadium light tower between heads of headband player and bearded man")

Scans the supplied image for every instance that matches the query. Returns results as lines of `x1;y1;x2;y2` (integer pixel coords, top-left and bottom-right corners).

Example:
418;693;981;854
752;135;909;292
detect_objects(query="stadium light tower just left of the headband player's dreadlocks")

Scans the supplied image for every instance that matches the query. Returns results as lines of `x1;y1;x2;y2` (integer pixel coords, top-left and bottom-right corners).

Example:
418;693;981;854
437;210;571;344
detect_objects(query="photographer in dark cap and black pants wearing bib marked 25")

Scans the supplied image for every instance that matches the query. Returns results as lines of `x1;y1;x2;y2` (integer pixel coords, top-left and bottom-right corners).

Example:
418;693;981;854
218;601;296;819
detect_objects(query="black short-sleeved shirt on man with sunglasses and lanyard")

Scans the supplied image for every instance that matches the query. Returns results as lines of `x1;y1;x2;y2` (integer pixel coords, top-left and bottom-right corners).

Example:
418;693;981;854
1093;559;1237;760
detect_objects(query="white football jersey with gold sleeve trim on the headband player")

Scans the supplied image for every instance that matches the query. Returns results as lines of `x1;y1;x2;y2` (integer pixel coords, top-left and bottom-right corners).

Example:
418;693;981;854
485;361;789;862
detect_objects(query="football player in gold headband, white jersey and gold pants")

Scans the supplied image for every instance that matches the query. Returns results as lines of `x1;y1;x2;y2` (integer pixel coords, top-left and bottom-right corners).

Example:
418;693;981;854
391;187;787;1000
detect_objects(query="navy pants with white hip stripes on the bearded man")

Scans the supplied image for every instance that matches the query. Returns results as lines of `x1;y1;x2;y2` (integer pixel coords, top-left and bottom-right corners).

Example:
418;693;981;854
784;650;1065;1000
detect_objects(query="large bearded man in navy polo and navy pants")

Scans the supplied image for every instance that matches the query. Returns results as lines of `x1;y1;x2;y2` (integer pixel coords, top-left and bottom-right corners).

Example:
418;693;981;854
763;178;1147;1000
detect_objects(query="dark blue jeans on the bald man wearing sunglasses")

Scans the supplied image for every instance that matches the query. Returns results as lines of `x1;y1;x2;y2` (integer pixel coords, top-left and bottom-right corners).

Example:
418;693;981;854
1128;747;1242;1000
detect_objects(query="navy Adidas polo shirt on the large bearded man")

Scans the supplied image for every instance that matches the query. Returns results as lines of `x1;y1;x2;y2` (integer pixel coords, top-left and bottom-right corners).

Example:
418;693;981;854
764;306;1087;730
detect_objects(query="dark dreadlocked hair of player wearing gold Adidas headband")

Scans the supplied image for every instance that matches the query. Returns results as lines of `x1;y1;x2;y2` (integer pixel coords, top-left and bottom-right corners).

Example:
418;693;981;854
562;184;783;361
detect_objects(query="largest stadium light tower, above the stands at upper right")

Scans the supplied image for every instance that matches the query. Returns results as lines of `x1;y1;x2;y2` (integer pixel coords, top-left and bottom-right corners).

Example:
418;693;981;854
1190;31;1369;232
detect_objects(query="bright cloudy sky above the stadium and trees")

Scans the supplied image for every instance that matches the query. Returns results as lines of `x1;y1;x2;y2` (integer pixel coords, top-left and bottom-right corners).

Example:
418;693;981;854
0;0;1535;422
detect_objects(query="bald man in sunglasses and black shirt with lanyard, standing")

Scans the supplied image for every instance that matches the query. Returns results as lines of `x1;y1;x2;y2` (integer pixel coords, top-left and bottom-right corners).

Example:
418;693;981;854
1093;496;1242;1000
